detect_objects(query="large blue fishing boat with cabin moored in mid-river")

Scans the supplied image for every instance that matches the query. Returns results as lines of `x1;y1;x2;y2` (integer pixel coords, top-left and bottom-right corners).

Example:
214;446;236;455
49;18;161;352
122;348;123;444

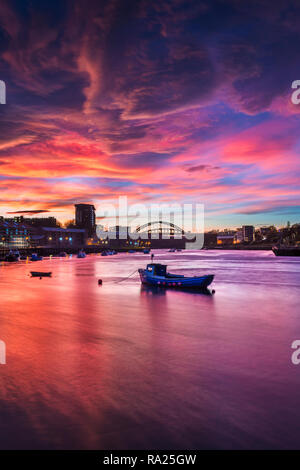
139;263;214;289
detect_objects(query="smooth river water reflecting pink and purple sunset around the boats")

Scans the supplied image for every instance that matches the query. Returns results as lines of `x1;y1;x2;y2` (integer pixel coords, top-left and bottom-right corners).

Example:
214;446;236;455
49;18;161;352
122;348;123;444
0;251;300;449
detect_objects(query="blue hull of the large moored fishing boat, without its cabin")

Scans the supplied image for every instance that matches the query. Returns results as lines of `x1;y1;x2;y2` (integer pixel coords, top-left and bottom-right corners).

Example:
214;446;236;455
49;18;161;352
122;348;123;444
139;269;214;289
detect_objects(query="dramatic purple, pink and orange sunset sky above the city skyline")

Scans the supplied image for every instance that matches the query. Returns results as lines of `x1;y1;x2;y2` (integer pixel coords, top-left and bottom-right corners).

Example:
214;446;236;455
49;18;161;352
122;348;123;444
0;0;300;229
